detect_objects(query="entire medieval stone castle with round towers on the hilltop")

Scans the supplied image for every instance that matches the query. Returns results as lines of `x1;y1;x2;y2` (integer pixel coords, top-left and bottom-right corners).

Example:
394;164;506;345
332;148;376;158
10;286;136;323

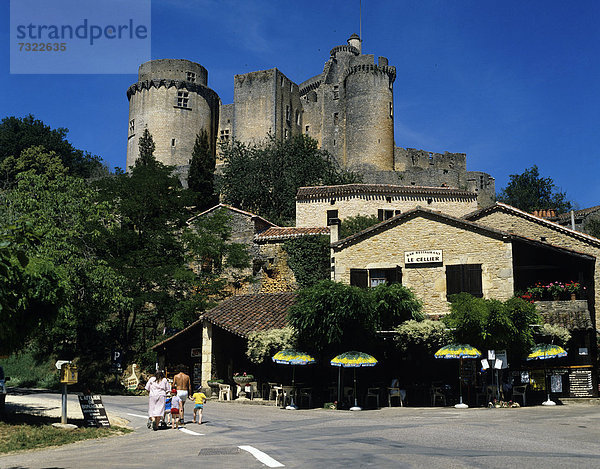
127;34;495;206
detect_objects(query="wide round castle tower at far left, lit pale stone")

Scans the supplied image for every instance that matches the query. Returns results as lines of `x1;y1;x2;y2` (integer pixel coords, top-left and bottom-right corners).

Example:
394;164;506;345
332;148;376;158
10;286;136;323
127;59;219;169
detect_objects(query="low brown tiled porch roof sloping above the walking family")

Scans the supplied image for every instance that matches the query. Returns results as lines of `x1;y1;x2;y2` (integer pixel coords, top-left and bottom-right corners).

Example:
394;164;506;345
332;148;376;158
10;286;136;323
203;292;296;337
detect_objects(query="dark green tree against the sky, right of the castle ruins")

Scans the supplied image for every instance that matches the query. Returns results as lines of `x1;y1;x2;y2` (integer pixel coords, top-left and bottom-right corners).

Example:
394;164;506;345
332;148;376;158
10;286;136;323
497;165;571;213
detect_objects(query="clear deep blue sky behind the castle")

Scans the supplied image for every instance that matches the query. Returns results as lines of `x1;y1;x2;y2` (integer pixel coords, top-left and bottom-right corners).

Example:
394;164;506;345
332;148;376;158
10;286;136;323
0;0;600;208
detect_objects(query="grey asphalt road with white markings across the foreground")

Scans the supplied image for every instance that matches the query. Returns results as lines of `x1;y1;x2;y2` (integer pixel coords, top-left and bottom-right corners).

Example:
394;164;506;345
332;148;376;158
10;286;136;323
0;396;600;469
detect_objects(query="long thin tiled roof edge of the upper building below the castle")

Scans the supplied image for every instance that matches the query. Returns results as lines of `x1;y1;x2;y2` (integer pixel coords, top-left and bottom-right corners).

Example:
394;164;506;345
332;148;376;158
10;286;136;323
296;184;477;200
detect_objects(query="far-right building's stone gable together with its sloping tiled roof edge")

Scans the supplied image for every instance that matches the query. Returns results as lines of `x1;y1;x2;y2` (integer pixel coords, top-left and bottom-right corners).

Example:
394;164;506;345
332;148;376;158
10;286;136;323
466;204;600;328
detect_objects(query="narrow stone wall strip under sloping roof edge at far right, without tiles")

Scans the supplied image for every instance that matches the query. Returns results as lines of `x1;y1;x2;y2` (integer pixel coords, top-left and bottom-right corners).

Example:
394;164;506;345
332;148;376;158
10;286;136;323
477;211;600;328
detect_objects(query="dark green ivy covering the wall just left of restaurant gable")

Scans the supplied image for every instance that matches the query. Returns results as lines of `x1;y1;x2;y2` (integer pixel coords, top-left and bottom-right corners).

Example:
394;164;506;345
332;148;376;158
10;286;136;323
283;236;330;288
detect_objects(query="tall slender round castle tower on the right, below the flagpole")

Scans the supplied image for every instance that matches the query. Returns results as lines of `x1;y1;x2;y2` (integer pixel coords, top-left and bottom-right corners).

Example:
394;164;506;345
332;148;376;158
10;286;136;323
343;58;396;171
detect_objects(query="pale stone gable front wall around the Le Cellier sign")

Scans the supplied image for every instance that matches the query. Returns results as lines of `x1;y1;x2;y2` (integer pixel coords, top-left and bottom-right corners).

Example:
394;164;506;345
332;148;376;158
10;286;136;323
332;210;514;316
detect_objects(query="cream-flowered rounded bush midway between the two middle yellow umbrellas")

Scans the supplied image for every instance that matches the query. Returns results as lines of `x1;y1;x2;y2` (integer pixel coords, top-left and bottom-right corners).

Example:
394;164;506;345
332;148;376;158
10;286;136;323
395;319;452;357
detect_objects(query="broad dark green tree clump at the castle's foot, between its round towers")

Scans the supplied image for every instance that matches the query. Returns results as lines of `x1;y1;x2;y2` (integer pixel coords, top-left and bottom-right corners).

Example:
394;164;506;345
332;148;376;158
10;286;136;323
219;135;360;225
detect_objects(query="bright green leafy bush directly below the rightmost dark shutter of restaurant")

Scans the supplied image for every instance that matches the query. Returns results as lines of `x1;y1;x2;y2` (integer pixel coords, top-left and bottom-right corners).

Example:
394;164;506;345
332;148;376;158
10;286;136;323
443;293;540;358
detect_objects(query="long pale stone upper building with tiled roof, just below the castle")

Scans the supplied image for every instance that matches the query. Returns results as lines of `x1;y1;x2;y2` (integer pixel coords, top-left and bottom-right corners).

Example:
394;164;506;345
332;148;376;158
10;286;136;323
296;184;477;227
